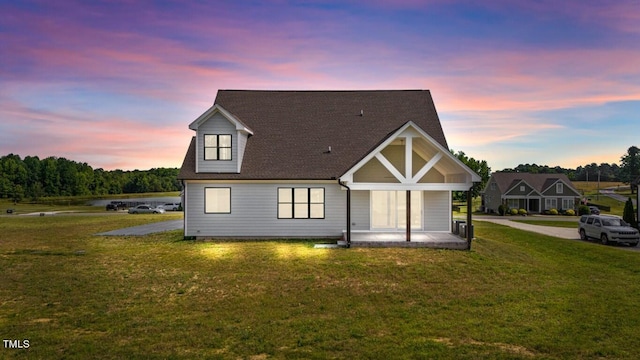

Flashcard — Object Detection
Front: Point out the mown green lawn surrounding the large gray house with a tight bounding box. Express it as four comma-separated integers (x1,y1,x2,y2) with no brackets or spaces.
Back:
0,214,640,359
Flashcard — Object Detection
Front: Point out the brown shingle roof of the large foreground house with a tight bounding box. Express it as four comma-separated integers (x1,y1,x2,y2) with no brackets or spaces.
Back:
179,90,448,180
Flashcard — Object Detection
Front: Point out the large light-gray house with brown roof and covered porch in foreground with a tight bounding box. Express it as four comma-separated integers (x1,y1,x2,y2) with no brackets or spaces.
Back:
179,90,480,246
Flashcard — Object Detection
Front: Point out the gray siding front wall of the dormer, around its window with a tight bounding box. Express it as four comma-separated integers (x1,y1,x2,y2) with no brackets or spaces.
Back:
196,113,239,173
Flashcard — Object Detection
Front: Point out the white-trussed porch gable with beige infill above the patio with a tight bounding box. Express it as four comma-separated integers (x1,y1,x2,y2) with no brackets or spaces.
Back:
340,121,481,191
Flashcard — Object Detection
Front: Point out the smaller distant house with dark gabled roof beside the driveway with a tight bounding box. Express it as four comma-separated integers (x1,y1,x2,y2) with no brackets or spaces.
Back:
483,172,581,213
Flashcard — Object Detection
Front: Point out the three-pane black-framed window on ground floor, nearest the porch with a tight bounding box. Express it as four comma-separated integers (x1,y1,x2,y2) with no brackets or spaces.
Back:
278,188,324,219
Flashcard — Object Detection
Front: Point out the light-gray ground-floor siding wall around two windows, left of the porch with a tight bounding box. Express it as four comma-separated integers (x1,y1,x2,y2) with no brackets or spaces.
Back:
185,182,347,238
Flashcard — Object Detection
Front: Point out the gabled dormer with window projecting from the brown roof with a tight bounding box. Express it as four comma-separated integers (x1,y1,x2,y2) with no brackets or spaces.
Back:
189,104,253,173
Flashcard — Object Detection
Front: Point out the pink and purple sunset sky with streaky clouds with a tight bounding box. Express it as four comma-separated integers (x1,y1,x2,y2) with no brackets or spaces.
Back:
0,0,640,170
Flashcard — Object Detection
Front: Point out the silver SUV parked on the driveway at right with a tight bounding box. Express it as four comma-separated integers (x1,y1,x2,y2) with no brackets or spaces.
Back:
578,215,640,246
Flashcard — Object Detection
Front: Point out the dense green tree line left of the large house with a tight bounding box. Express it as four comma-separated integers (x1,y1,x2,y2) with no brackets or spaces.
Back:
0,154,182,202
